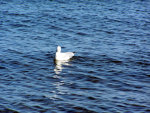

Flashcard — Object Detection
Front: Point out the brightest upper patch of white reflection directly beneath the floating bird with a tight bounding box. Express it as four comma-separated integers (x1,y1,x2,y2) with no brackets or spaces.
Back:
54,60,71,74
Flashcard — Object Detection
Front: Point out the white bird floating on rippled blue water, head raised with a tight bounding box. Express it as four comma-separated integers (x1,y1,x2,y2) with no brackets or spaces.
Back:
55,46,74,61
